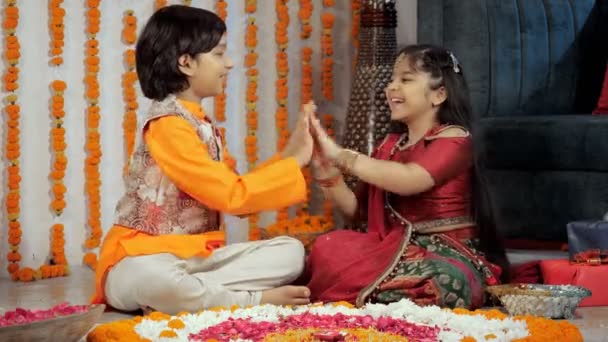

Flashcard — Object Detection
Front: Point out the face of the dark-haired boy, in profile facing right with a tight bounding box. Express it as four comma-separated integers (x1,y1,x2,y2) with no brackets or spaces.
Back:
183,35,233,98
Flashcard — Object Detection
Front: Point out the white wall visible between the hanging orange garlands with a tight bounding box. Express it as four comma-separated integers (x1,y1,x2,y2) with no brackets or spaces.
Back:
0,0,416,277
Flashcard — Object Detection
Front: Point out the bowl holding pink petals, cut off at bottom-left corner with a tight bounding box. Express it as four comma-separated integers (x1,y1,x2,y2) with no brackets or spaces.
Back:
0,304,105,342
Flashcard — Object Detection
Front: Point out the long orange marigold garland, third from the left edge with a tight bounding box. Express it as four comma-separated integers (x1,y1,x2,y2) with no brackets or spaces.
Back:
83,0,103,269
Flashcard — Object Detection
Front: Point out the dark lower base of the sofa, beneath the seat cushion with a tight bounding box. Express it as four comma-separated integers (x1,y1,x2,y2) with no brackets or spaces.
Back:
486,169,608,242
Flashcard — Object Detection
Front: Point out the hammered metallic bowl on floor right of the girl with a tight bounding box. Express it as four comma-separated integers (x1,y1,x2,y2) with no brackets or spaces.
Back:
487,284,591,319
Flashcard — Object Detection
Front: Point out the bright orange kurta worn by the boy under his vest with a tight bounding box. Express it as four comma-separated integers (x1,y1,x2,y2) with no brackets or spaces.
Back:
92,100,306,303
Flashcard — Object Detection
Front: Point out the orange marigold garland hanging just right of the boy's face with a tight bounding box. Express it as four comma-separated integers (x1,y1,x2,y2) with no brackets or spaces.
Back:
245,0,260,230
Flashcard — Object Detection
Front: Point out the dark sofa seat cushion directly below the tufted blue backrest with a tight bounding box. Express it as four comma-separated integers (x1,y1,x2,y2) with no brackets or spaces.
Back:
475,115,608,174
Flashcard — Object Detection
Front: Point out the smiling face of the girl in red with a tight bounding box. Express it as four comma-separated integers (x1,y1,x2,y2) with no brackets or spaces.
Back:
386,55,445,123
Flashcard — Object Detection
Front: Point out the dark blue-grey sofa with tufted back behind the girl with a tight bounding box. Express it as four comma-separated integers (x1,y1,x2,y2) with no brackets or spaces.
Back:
417,0,608,245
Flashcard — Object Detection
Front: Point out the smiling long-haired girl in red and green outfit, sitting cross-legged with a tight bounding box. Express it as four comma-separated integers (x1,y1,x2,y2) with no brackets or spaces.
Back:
304,45,507,308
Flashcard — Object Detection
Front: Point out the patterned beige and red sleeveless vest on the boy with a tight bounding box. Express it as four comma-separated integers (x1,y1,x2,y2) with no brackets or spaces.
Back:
114,96,222,235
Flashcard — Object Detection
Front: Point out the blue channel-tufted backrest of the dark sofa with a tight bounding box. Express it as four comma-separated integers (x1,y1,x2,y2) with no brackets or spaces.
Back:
417,0,608,117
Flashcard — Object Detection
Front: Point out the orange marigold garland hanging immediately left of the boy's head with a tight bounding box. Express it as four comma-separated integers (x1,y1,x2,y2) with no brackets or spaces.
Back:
122,10,138,172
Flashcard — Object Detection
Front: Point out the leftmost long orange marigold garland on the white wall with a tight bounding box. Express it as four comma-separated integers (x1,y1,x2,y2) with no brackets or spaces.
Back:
2,0,22,280
